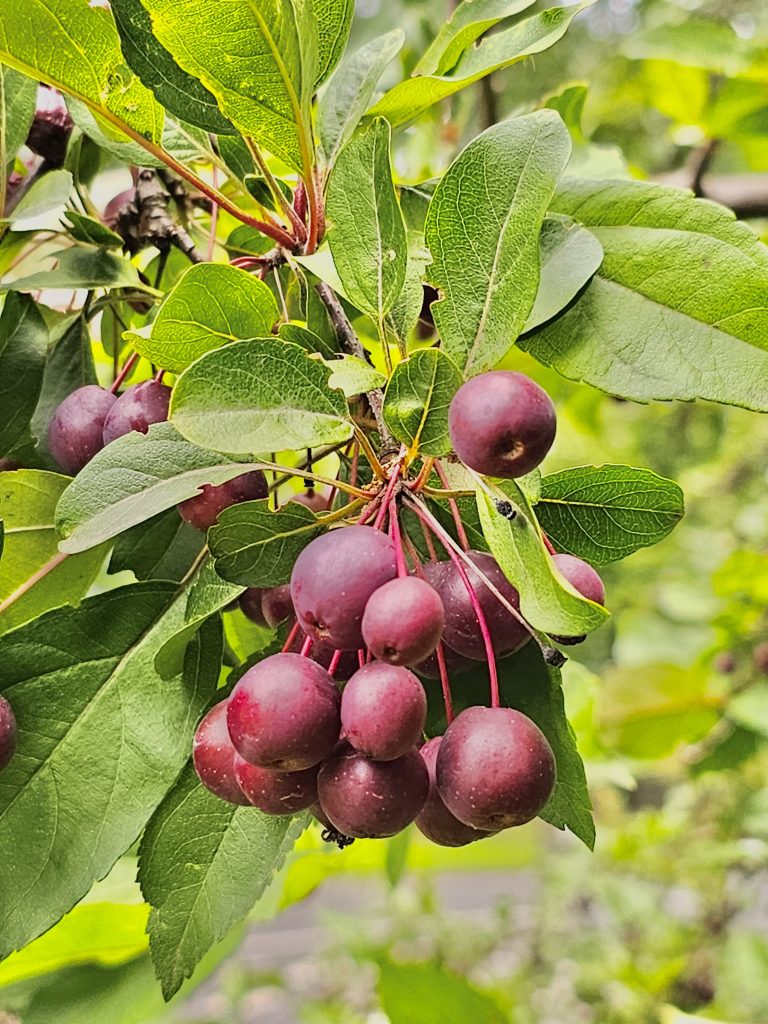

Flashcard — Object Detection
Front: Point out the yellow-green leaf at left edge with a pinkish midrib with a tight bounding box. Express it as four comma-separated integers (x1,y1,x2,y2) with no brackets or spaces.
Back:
0,469,103,632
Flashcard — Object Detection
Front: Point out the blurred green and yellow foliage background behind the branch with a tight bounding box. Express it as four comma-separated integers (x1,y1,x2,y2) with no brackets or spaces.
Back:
0,0,768,1024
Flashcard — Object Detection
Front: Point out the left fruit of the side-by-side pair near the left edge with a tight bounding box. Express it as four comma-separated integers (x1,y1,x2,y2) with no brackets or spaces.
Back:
48,384,117,476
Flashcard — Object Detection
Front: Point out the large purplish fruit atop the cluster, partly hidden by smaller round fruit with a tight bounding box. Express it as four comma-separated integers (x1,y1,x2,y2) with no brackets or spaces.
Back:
291,526,397,650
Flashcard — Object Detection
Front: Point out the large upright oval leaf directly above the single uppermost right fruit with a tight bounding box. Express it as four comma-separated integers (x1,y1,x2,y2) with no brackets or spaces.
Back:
425,111,570,376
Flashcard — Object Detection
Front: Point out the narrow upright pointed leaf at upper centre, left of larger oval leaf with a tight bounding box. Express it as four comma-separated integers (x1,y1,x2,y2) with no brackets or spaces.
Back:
327,118,408,324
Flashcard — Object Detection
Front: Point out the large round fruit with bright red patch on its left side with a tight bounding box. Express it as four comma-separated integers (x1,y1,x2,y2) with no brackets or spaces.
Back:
227,653,341,771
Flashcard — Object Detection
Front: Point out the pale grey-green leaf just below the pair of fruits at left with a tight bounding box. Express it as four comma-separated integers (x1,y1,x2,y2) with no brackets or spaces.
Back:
56,423,250,554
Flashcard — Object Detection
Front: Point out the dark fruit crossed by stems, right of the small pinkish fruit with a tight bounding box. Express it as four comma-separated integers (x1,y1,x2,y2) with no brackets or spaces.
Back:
423,551,530,662
